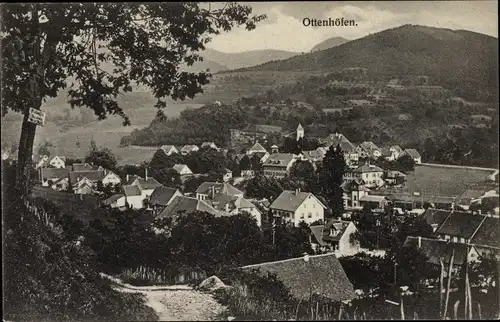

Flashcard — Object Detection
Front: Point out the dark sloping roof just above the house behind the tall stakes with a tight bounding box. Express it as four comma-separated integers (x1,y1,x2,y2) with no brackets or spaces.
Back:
436,211,486,238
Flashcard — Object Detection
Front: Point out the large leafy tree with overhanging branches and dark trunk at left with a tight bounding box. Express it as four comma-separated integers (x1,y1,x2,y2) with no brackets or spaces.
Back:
0,2,265,194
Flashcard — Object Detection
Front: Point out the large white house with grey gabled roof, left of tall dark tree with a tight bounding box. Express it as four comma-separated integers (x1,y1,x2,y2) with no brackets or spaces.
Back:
270,189,326,226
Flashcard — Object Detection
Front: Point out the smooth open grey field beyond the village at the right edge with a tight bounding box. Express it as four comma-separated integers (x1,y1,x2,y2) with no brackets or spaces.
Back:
406,164,494,197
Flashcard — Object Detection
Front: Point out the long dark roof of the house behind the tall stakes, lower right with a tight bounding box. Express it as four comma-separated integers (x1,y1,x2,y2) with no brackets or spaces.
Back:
404,236,471,265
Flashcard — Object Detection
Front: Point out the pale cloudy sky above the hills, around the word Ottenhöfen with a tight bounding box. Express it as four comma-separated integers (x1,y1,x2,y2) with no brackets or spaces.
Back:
207,1,498,53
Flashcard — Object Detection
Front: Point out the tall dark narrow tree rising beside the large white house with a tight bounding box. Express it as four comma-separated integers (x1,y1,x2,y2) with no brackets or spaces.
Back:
318,146,346,217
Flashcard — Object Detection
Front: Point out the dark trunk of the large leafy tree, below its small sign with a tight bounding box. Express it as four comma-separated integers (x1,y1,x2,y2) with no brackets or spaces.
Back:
16,109,36,196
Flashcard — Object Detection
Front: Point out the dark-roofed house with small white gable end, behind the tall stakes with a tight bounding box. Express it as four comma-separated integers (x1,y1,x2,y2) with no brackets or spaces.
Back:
404,236,479,274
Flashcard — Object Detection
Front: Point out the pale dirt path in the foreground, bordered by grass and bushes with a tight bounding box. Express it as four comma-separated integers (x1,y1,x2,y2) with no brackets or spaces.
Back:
101,274,225,321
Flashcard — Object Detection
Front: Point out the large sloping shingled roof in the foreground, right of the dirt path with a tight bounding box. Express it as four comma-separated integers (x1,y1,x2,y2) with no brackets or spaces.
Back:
241,253,357,302
